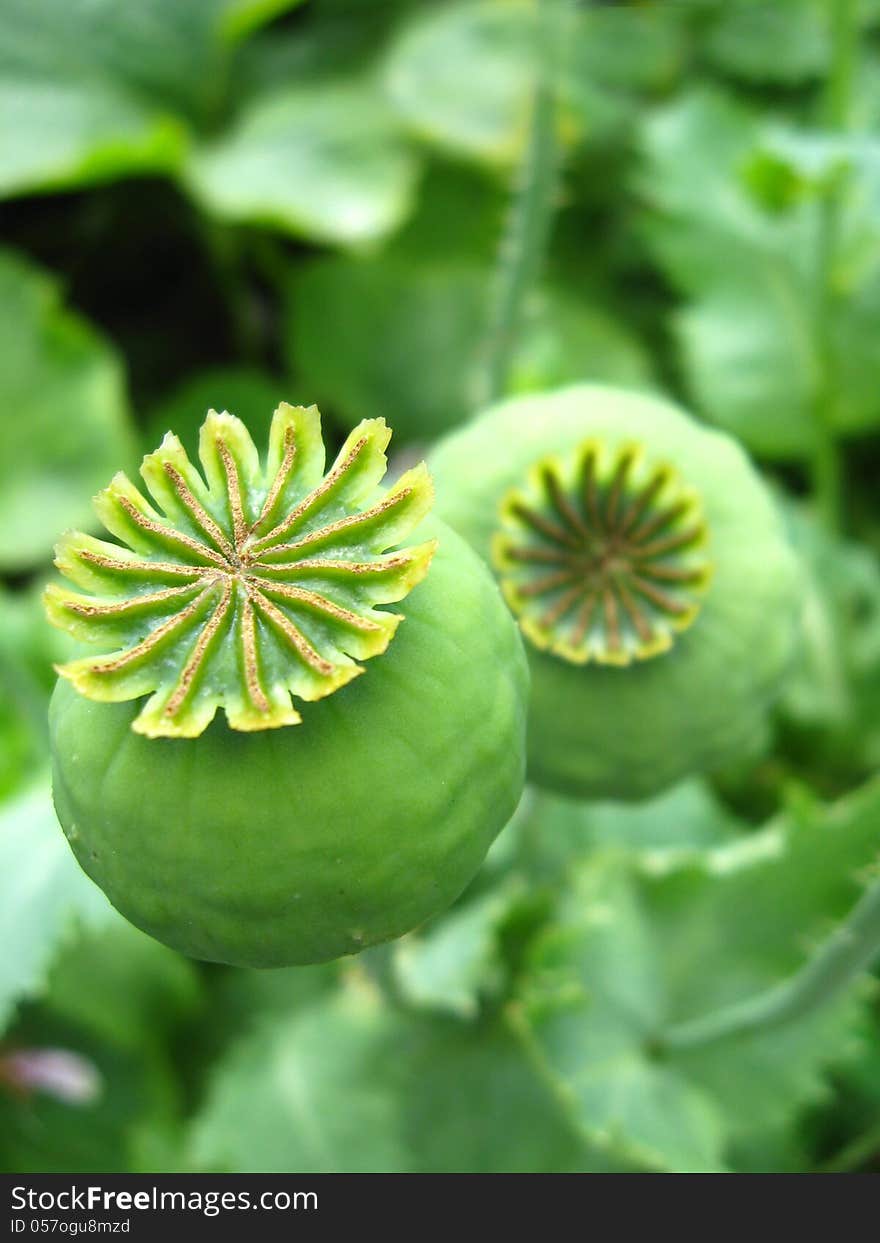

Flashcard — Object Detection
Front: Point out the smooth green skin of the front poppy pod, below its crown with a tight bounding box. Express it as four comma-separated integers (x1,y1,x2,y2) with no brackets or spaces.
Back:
50,523,528,967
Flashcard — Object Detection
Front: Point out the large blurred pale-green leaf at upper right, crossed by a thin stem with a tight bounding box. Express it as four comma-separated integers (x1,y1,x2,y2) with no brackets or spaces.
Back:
639,89,880,457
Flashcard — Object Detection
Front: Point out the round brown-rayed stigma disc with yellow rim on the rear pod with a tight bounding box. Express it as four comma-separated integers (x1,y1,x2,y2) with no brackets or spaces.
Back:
492,440,711,666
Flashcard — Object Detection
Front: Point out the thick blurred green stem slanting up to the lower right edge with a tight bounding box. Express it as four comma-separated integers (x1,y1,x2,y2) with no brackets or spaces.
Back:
660,879,880,1050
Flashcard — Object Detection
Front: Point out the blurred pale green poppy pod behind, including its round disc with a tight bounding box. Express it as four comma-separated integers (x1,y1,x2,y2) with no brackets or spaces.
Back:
431,385,798,799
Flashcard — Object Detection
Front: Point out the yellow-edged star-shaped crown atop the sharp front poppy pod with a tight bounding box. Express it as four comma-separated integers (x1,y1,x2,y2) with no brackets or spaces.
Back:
45,404,435,737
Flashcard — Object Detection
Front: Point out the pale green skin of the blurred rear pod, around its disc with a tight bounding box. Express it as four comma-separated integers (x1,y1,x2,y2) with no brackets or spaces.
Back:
430,384,799,799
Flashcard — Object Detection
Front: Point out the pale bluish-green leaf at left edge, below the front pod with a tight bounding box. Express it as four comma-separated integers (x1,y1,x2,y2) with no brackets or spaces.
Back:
0,778,114,1028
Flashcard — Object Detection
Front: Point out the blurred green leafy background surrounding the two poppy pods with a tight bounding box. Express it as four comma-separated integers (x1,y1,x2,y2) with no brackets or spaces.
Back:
0,0,880,1171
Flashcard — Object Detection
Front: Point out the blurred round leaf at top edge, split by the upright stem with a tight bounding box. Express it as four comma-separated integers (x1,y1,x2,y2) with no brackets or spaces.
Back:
384,0,685,169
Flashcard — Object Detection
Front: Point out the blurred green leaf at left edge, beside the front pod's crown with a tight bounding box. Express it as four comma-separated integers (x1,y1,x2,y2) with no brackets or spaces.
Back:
0,251,134,571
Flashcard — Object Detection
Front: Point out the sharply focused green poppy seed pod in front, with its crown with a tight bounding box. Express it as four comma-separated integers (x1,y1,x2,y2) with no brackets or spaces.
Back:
46,405,528,967
